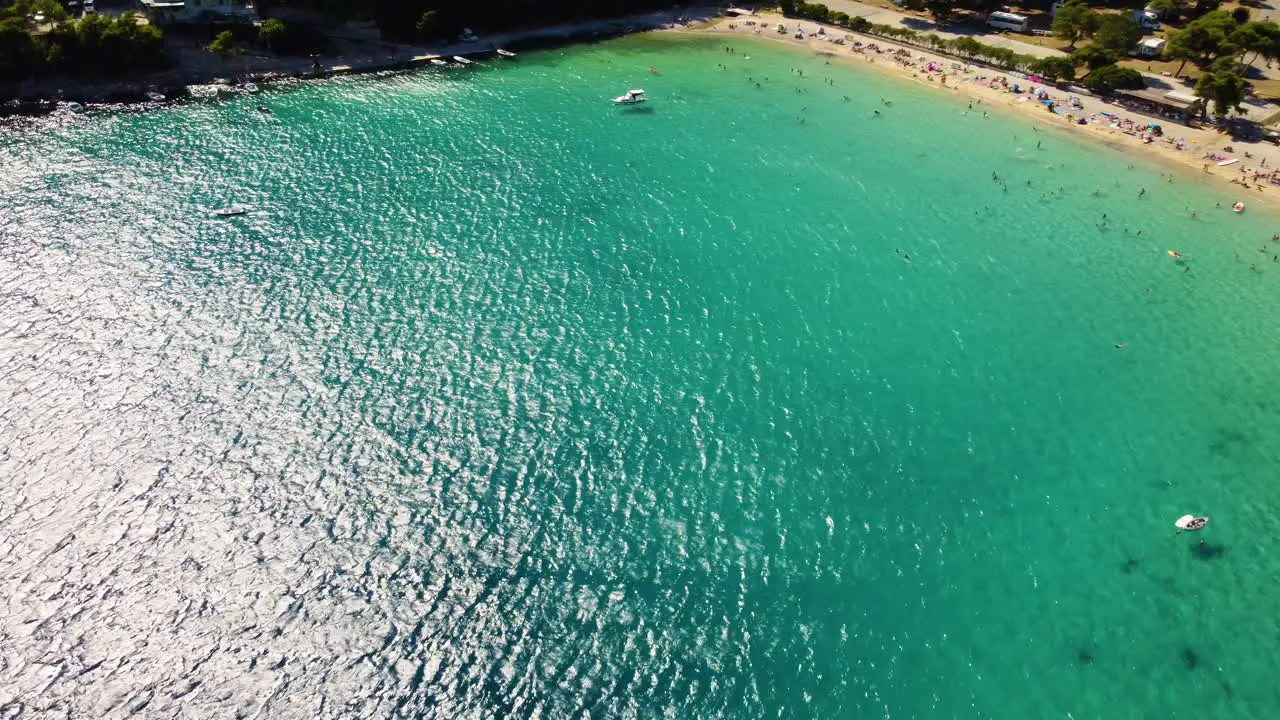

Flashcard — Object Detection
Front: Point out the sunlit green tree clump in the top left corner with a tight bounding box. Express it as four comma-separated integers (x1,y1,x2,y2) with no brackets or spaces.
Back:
0,0,168,82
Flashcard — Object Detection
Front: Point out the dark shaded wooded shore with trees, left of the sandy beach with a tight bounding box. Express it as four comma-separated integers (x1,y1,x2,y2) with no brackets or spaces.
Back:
0,0,716,111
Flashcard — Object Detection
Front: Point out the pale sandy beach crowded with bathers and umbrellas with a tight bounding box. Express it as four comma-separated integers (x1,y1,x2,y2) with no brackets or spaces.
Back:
663,13,1280,208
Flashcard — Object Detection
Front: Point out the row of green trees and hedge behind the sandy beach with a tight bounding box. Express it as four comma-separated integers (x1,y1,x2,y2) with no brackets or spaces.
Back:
781,0,1280,115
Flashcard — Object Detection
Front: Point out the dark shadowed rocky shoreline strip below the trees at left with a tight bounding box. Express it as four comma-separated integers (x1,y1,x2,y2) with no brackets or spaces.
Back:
0,8,716,118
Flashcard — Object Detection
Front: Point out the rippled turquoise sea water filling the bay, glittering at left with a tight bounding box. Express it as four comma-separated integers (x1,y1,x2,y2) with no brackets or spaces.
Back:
0,37,1280,719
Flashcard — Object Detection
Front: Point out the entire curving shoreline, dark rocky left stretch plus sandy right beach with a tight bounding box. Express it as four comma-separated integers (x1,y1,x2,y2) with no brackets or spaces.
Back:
10,8,1280,209
